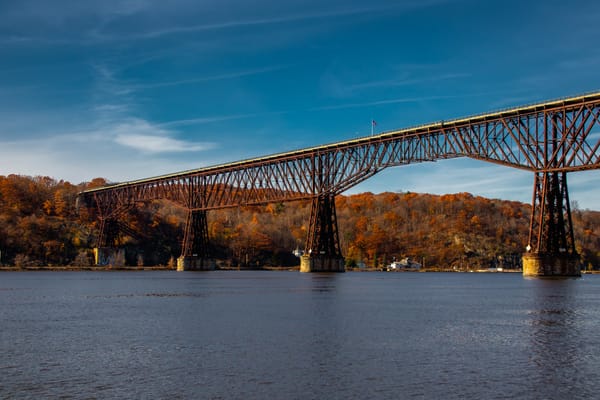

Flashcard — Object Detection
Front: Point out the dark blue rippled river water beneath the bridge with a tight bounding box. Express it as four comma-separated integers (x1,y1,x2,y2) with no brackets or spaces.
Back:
0,271,600,399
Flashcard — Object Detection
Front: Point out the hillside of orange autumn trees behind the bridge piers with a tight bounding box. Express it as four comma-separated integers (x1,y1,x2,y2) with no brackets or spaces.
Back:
0,175,600,268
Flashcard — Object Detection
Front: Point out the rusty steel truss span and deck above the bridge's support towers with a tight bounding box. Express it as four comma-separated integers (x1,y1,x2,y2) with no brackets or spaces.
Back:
80,92,600,212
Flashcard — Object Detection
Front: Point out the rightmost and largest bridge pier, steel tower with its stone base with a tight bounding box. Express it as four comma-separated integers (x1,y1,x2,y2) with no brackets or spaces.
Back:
523,172,581,277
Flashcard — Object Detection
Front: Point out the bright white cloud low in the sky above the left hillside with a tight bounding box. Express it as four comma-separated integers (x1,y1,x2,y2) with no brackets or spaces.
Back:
0,114,217,183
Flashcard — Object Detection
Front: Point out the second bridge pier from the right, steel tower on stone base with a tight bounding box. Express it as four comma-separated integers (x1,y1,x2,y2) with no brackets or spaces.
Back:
300,194,346,272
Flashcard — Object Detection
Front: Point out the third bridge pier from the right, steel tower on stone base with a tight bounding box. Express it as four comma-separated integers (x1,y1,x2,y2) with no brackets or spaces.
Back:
177,210,216,271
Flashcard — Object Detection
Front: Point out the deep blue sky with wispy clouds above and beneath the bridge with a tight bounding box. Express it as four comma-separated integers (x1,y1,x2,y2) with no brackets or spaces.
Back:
0,0,600,210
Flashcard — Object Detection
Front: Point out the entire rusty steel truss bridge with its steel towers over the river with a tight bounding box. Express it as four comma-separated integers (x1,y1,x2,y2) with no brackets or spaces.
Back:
80,92,600,276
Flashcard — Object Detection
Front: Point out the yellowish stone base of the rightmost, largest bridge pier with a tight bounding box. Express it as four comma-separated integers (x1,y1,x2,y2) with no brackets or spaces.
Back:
523,253,581,277
